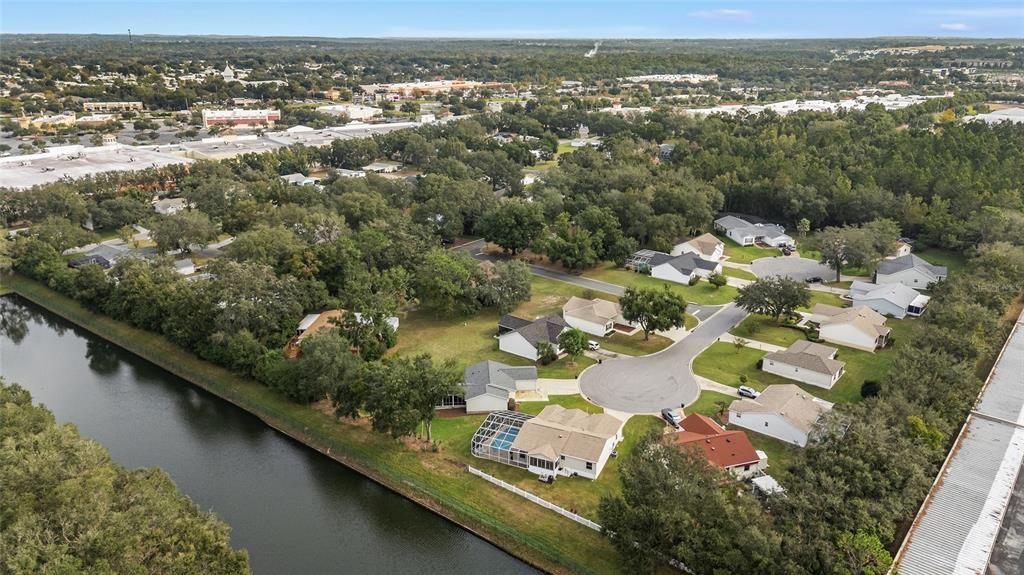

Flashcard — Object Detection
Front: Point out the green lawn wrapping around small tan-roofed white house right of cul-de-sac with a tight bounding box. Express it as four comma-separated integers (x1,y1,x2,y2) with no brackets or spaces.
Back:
693,319,913,403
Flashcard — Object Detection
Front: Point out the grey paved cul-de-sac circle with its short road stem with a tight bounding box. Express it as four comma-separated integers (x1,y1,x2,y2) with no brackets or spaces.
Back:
580,304,746,413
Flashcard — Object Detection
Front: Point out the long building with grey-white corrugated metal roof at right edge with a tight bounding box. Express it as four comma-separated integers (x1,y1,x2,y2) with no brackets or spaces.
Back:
894,308,1024,575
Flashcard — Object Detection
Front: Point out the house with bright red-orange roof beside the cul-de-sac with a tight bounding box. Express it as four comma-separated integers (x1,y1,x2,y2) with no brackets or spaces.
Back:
673,413,768,479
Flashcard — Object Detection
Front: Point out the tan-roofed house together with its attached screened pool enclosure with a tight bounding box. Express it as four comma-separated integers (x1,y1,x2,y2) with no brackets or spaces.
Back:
470,405,625,479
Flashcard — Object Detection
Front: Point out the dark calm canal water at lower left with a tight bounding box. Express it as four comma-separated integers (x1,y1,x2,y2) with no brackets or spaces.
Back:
0,298,534,575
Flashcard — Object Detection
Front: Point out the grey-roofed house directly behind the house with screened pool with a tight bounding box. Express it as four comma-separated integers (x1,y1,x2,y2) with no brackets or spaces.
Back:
438,359,537,413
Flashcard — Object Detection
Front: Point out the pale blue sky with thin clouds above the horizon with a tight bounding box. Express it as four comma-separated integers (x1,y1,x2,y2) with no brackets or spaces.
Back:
6,0,1024,39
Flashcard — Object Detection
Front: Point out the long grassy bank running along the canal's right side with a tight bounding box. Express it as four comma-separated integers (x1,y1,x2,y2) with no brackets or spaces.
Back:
5,276,617,573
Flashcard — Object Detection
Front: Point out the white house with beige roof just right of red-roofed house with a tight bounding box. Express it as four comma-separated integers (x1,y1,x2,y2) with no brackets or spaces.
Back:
729,384,833,447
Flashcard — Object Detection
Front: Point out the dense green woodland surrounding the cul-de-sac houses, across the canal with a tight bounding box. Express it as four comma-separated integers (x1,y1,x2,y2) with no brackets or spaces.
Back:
6,95,1024,574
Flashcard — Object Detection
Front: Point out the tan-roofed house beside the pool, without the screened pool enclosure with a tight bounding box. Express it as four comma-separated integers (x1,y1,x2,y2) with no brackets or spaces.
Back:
511,405,624,479
